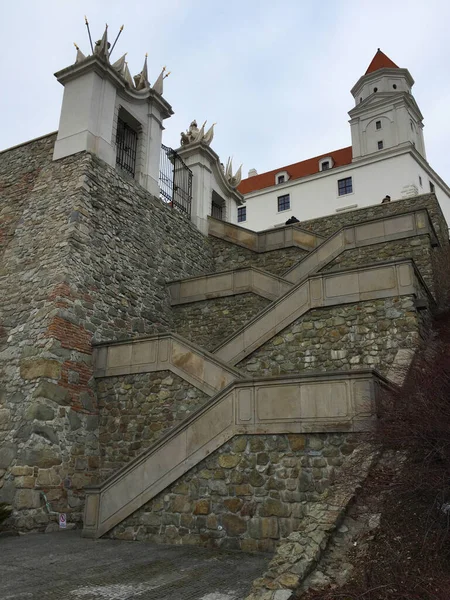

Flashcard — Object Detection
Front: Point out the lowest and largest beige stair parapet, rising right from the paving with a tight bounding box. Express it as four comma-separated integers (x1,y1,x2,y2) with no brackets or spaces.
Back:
83,369,389,537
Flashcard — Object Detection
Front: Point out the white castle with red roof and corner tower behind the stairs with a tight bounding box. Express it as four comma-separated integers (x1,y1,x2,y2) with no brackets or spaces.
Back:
236,49,450,231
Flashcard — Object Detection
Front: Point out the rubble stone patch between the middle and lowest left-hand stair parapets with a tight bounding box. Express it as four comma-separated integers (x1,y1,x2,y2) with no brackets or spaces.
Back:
173,294,270,352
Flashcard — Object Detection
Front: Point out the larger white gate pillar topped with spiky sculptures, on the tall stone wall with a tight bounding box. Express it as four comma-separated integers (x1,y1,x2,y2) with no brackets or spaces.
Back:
53,27,173,196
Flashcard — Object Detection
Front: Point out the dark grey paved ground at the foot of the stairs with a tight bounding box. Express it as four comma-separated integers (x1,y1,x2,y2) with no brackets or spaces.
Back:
0,531,270,600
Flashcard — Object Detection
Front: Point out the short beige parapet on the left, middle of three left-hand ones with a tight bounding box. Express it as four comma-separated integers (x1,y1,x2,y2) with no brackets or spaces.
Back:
168,267,293,306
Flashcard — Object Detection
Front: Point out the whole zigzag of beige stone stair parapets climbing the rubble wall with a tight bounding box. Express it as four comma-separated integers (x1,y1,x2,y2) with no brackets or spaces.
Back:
83,209,436,537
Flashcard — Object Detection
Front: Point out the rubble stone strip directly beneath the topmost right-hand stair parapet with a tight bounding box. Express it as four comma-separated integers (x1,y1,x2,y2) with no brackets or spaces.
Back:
321,235,434,292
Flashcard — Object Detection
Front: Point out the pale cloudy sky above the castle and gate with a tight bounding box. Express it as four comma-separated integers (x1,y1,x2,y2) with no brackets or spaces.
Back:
0,0,450,184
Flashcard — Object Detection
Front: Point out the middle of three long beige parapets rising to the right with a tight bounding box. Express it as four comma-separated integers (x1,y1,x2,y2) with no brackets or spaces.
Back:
214,259,430,364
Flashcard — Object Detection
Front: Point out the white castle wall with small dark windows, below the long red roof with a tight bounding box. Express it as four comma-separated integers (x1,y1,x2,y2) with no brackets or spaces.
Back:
237,152,450,231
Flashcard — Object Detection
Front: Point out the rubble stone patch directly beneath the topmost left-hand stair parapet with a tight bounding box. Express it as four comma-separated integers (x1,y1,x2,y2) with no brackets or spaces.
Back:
209,236,308,275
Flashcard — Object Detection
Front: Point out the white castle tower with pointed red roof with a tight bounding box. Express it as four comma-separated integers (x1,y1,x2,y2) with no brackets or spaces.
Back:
349,48,425,162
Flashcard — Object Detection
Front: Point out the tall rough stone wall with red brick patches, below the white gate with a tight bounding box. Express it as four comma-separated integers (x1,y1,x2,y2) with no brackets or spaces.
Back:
0,138,213,527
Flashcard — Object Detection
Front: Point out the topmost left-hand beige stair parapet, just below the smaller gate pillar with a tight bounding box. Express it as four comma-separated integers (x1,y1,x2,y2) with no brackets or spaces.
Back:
208,216,324,253
